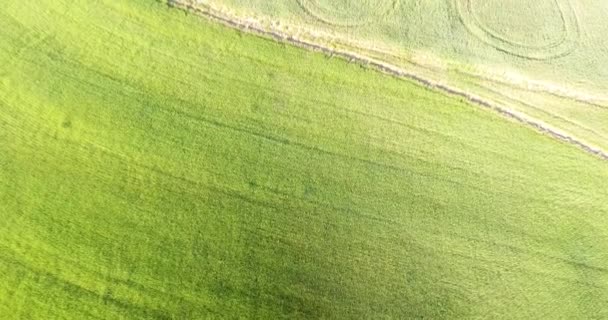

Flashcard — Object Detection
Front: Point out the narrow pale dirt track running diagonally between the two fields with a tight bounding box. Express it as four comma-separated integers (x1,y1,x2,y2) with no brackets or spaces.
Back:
167,0,608,160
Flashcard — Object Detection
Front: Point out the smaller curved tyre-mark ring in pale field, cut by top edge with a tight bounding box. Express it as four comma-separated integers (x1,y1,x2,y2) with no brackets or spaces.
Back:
296,0,400,27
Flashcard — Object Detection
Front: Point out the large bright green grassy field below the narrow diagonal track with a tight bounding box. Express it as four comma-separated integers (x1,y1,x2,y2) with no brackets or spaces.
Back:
0,0,608,319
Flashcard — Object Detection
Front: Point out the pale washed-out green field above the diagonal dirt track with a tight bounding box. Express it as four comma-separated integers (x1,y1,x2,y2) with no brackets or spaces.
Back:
196,0,608,150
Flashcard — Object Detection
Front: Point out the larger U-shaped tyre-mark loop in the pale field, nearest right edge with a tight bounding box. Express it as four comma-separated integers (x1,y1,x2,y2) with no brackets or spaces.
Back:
453,0,580,60
